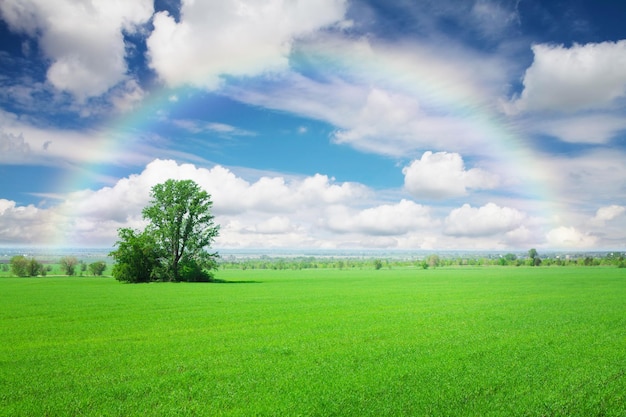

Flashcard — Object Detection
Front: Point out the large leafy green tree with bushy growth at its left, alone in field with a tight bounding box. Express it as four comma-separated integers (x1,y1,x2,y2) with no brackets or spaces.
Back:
111,179,219,282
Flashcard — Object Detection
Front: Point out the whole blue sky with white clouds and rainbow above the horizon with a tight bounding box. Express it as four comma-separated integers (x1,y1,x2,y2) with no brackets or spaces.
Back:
0,0,626,251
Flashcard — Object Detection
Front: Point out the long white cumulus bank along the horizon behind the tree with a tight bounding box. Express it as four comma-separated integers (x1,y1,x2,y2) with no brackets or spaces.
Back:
0,160,624,250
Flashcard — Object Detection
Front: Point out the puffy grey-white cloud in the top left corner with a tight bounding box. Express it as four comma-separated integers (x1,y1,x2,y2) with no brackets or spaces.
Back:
0,0,154,101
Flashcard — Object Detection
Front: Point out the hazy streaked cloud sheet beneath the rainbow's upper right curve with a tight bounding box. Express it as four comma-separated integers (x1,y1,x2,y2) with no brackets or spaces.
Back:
224,34,510,156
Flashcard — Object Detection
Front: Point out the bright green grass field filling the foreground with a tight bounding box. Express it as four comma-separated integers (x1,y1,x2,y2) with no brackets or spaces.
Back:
0,267,626,416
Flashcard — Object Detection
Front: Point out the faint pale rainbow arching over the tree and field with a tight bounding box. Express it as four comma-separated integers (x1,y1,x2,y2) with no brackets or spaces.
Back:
54,46,558,247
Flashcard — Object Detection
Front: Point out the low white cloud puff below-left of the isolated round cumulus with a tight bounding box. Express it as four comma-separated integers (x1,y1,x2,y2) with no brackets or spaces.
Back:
321,200,437,236
